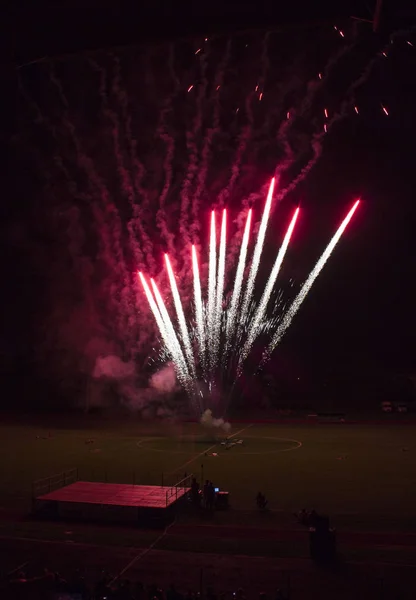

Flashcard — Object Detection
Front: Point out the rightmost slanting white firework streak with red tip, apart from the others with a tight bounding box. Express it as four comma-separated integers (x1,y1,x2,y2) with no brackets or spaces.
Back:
261,200,360,364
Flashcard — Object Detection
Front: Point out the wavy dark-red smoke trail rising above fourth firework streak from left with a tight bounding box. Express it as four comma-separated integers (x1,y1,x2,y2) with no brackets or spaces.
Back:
191,39,231,241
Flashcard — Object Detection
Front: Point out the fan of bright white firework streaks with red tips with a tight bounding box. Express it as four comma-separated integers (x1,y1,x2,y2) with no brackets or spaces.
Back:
139,178,360,413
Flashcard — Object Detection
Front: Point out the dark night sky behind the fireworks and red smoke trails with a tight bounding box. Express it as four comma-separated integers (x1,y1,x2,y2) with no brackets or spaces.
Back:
0,3,416,406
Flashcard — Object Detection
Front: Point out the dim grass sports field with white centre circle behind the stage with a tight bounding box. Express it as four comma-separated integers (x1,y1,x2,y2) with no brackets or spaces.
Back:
0,420,416,518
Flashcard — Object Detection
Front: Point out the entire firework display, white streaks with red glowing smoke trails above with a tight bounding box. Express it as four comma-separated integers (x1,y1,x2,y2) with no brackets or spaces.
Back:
13,20,415,417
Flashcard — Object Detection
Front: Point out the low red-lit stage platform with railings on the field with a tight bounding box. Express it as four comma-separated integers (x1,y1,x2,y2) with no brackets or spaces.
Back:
33,478,190,527
